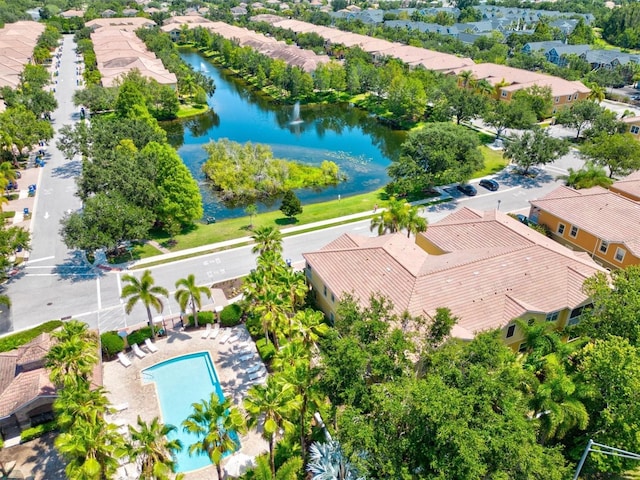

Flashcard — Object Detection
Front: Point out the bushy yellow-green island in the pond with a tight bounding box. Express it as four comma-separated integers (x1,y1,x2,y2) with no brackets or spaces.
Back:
202,138,346,203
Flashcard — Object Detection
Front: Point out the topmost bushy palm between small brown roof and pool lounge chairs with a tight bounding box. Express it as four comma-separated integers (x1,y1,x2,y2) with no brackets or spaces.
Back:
45,320,98,386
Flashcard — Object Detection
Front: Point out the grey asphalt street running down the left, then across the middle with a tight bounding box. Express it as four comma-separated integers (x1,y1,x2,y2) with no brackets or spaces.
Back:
0,36,582,333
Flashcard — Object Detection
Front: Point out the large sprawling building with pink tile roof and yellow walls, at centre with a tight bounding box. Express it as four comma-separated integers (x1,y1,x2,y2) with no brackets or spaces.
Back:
304,208,605,349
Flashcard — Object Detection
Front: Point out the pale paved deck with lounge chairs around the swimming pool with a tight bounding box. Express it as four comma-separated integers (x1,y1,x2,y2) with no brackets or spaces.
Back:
103,325,268,480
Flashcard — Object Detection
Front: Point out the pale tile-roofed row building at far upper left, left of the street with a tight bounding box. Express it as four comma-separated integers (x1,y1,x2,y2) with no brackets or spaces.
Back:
0,20,44,88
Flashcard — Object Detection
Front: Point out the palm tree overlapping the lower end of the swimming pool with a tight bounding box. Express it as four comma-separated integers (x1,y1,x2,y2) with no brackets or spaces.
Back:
182,392,246,480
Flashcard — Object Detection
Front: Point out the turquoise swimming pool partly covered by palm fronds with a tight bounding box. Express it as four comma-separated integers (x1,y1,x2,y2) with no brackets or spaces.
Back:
142,352,239,472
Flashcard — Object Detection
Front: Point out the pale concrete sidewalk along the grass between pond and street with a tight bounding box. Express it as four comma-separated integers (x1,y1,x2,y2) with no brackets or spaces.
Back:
129,188,452,268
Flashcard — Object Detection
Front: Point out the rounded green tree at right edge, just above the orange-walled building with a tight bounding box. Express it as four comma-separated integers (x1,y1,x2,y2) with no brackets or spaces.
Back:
580,133,640,178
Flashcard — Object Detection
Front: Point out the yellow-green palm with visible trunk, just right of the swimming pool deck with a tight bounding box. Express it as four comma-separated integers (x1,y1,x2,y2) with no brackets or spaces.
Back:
244,376,300,476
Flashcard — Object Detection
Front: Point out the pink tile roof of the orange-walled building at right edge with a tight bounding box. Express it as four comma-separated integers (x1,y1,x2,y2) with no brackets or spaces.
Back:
530,187,640,256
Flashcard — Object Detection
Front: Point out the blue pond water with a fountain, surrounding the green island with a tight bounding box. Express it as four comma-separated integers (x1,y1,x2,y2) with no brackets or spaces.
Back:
163,51,405,219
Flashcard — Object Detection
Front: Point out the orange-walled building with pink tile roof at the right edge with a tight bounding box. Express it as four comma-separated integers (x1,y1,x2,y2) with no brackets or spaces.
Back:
529,187,640,269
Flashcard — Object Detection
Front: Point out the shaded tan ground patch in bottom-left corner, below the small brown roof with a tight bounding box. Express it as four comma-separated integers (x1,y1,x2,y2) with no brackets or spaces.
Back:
0,433,67,480
